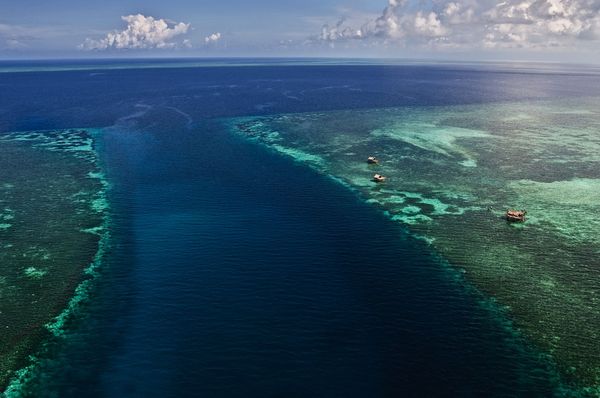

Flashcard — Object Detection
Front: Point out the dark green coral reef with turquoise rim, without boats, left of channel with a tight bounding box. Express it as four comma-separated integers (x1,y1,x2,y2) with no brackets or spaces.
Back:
0,129,108,396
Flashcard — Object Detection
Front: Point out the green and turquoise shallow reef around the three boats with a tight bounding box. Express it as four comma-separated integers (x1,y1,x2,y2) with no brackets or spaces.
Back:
225,97,600,392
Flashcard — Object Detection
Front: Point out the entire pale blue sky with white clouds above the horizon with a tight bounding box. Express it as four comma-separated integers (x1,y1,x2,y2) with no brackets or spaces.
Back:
0,0,600,64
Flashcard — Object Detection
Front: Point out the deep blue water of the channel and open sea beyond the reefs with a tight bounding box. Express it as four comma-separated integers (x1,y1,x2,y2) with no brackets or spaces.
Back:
0,60,600,397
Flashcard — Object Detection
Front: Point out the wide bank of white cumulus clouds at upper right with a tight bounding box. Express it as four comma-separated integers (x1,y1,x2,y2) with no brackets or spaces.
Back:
309,0,600,51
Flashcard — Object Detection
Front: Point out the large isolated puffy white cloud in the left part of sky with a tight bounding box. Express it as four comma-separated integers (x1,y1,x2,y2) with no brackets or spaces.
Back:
79,14,190,50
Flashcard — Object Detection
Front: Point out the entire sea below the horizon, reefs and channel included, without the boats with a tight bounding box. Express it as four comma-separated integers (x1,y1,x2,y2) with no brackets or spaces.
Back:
0,59,600,397
